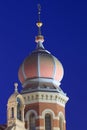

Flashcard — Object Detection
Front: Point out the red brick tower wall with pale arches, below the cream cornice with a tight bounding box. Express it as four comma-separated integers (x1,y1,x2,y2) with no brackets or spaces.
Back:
25,102,65,130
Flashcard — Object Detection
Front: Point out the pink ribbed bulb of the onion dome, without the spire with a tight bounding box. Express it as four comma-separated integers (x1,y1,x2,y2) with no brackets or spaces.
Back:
18,48,64,86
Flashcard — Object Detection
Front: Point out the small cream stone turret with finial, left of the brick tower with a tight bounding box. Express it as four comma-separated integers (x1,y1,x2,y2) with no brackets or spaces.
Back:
6,83,25,130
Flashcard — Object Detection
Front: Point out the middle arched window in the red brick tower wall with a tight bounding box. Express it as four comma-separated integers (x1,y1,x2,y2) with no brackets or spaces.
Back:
45,114,52,130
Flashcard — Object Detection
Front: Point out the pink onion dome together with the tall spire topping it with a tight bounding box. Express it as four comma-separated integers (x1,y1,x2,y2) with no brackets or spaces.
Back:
18,4,64,88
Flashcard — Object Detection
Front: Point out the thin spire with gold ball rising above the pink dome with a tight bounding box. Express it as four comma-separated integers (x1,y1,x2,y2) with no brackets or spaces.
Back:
35,4,44,49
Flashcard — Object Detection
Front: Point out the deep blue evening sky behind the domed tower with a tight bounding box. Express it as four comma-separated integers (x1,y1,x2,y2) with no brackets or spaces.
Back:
0,0,87,130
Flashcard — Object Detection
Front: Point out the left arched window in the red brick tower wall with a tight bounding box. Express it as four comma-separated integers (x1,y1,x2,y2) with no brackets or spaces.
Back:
29,113,36,130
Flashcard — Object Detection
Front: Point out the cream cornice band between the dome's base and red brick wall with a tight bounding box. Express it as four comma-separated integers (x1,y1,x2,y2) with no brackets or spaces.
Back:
22,92,68,107
